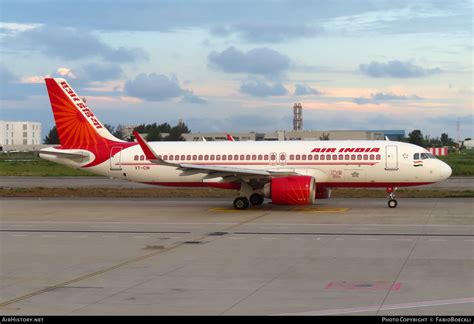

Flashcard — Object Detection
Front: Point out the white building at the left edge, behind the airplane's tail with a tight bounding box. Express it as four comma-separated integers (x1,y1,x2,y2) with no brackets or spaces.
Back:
0,120,41,150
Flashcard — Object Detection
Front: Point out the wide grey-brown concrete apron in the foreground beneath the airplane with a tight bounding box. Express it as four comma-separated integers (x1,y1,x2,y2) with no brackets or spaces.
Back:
0,198,474,315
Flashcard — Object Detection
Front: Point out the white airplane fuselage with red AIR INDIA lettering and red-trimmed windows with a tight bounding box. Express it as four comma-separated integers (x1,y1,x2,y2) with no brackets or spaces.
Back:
40,141,451,187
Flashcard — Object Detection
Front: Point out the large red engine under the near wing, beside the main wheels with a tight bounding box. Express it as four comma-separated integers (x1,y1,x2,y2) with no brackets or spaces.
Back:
263,176,316,205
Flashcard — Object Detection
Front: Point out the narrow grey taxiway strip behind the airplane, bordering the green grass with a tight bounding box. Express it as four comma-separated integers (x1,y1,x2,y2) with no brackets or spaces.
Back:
0,176,474,190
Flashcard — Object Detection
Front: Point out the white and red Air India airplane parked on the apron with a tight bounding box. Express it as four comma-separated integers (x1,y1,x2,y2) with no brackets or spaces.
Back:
39,78,451,210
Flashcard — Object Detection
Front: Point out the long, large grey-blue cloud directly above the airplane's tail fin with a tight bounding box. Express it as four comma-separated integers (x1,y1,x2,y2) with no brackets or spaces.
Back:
5,26,147,62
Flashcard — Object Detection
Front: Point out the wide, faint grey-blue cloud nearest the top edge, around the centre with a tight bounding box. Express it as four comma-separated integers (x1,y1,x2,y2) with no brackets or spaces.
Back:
210,20,323,43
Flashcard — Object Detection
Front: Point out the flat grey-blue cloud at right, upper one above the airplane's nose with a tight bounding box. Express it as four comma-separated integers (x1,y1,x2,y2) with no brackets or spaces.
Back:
359,60,442,78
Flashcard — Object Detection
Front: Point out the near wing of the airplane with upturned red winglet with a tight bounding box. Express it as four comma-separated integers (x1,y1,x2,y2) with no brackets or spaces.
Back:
133,132,296,181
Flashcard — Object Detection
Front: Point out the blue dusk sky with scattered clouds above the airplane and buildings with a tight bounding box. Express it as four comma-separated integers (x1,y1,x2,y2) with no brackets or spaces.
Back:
0,0,474,139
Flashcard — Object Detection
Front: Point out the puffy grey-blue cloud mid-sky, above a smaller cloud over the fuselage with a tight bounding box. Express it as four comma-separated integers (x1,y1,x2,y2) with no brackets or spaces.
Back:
208,46,290,76
